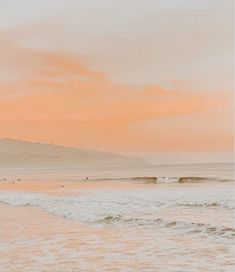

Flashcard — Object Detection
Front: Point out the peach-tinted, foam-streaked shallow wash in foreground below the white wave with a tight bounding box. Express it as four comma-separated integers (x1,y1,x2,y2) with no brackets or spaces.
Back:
0,201,233,272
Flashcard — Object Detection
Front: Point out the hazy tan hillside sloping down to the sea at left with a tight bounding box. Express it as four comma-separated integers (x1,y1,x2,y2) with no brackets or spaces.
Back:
0,139,144,168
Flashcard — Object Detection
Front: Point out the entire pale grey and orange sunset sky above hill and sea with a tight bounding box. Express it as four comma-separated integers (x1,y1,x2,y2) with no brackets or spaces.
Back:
0,0,234,163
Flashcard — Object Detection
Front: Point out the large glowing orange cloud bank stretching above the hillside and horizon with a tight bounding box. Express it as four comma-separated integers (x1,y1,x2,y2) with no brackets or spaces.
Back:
0,33,232,152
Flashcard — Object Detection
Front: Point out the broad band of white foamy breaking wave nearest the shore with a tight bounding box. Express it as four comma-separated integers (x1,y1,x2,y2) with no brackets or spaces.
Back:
0,186,234,242
